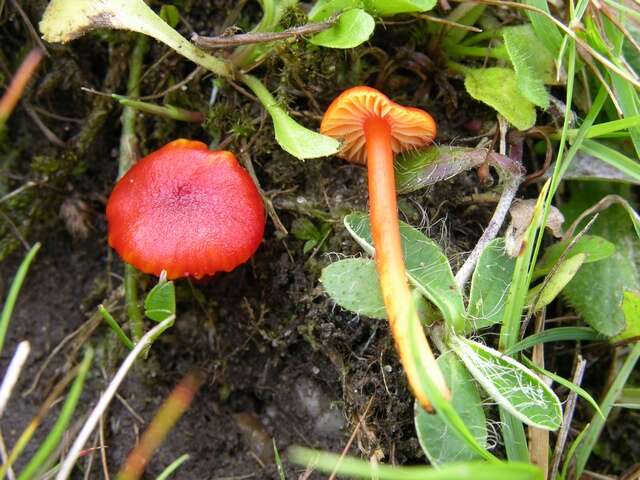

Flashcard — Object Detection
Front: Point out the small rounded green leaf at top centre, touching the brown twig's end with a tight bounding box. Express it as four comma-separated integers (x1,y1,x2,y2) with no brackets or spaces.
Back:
309,8,376,48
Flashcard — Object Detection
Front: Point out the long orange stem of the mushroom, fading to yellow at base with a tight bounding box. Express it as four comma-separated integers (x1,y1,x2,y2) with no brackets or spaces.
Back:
364,117,450,410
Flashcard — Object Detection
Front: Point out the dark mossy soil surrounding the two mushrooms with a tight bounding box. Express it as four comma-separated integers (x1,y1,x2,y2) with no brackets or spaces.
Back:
0,0,637,479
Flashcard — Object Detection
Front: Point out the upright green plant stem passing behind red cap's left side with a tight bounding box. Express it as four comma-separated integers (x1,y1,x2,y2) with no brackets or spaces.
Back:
118,35,149,342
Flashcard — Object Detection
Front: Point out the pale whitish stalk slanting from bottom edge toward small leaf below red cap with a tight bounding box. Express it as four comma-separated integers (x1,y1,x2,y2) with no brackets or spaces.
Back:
56,315,175,480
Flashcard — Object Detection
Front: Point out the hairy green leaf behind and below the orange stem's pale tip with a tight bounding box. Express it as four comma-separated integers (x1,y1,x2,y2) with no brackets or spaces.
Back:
414,352,487,466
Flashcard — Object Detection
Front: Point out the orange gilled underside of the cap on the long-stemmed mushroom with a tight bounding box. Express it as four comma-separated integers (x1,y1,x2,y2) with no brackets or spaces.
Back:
320,87,436,164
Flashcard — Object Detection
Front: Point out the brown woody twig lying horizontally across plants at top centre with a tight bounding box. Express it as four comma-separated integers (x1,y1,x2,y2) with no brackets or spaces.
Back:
191,17,337,49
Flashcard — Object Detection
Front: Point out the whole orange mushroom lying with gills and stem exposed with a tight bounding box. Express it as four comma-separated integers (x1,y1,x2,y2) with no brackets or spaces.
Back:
320,87,450,410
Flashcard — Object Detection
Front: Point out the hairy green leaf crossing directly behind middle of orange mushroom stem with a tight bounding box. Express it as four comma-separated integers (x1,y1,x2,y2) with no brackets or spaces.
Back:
344,213,464,329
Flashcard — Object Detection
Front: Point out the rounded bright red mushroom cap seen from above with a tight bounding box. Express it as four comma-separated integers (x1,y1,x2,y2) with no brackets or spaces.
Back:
107,140,265,279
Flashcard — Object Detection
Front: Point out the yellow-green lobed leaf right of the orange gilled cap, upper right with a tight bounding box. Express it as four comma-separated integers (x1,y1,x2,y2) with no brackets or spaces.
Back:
464,67,536,130
